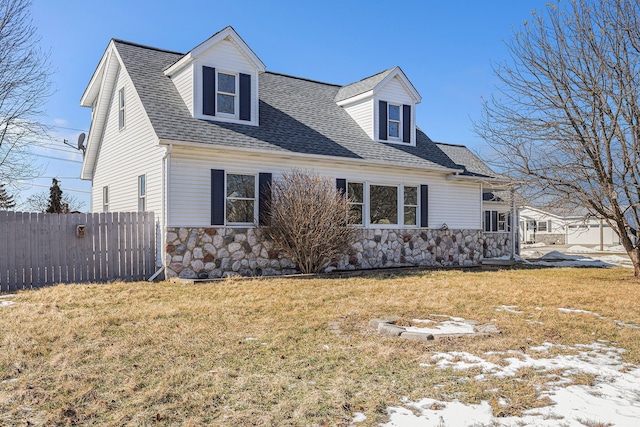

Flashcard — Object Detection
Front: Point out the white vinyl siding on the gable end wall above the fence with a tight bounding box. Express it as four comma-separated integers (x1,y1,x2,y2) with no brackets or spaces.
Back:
91,69,165,219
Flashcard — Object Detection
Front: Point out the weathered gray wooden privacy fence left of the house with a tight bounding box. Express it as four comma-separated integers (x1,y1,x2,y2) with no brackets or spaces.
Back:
0,210,156,291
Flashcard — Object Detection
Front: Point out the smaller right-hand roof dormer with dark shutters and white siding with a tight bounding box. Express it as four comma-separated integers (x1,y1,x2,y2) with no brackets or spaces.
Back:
335,67,422,146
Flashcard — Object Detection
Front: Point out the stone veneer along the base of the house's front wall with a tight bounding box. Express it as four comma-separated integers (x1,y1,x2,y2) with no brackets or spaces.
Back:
165,227,511,279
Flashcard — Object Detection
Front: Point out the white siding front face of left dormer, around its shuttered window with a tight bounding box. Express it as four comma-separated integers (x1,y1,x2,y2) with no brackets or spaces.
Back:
192,40,259,125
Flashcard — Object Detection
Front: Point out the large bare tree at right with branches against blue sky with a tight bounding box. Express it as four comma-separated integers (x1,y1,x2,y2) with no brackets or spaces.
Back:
474,0,640,278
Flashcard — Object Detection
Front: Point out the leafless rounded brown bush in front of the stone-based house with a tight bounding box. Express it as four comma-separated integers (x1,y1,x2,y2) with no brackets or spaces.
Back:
261,170,358,273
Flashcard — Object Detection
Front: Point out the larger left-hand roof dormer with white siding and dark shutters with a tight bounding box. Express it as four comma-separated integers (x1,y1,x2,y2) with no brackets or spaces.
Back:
164,27,265,126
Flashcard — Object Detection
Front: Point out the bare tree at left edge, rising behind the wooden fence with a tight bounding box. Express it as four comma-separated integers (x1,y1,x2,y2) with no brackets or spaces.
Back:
0,0,51,187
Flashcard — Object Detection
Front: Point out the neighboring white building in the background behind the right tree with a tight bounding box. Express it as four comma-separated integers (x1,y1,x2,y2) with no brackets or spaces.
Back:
519,206,620,245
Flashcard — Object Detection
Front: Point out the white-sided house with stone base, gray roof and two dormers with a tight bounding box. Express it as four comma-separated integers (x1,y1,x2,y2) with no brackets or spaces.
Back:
81,27,511,278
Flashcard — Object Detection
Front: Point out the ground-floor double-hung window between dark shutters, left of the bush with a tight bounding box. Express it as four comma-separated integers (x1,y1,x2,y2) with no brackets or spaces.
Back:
226,173,256,224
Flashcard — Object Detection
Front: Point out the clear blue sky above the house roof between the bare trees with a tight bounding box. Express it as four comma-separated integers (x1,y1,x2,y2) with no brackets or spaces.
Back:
20,0,546,210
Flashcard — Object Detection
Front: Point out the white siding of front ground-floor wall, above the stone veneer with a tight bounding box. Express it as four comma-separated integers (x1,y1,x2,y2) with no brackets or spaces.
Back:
167,146,482,229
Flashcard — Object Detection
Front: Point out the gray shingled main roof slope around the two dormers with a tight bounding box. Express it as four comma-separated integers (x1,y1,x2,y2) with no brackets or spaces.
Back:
114,40,461,169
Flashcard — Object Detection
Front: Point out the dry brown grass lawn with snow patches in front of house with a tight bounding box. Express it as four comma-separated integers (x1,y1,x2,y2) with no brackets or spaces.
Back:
0,269,640,426
